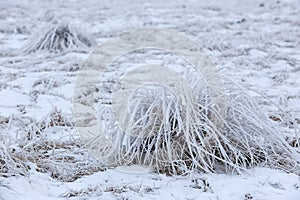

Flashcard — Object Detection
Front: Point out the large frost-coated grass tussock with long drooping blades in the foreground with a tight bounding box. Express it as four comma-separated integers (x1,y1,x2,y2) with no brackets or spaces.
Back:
90,69,300,174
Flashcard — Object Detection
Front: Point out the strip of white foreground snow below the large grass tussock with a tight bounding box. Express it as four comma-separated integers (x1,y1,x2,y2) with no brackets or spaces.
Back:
0,168,300,200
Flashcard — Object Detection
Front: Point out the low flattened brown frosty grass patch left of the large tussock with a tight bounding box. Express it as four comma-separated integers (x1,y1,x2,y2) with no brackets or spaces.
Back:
0,109,104,181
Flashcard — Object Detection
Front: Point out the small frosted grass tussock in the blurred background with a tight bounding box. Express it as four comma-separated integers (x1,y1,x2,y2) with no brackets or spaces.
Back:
23,22,92,53
